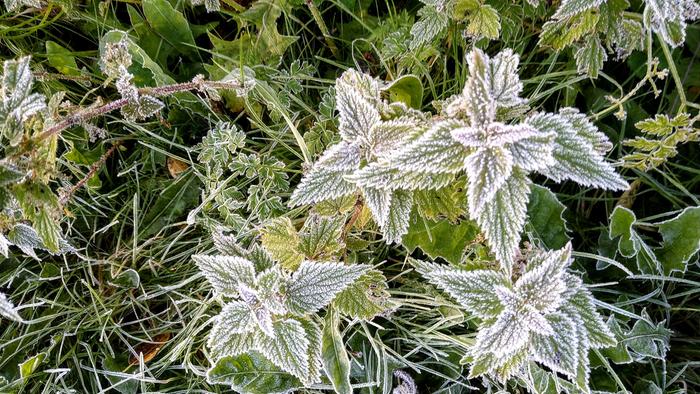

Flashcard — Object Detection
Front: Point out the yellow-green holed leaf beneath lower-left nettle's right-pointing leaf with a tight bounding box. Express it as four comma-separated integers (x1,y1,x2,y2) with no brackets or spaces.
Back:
333,270,390,320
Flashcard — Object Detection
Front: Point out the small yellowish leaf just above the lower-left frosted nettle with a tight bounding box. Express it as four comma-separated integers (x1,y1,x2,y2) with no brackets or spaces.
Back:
261,217,304,270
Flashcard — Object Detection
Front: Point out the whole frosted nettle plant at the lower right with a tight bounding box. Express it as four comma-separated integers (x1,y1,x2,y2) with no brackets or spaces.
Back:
414,244,616,392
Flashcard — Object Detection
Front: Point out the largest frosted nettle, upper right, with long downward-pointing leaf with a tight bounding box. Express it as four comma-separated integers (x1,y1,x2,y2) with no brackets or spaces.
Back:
352,49,627,272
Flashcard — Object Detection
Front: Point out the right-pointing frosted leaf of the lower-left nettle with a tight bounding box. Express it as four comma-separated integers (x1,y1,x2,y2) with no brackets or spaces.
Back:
287,261,370,315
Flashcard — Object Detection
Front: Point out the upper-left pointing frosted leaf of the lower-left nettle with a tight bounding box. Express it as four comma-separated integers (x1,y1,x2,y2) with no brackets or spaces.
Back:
192,255,255,297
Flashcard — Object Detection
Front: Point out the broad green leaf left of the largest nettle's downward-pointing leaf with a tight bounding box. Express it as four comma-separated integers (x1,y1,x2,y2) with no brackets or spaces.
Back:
401,218,479,264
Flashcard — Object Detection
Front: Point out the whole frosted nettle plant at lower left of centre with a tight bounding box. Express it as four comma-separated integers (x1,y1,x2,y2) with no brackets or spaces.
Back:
193,248,370,384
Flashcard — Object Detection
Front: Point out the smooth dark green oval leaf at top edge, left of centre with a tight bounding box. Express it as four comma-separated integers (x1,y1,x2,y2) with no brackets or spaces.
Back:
142,0,196,54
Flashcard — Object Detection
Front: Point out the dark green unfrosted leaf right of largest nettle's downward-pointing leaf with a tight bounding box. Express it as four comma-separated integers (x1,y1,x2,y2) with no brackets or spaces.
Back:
526,184,571,249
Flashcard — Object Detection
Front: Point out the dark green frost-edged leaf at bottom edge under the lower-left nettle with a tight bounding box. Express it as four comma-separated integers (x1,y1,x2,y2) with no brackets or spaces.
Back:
207,351,303,394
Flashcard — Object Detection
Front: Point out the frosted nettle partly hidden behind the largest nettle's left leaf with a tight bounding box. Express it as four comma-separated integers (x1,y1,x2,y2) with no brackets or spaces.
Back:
290,70,428,243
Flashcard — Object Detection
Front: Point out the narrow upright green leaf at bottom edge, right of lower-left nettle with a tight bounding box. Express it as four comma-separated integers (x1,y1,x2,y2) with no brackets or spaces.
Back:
321,308,353,394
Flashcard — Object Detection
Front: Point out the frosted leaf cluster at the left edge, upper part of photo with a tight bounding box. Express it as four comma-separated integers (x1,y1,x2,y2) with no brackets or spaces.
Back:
0,56,46,146
